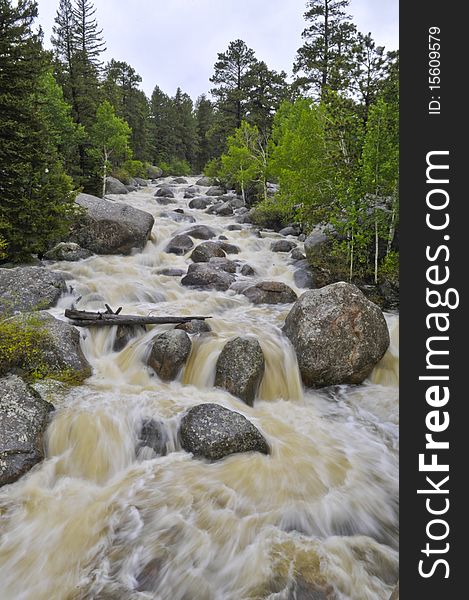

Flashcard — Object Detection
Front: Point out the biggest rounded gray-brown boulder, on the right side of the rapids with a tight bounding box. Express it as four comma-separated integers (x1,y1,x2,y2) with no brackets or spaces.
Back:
283,282,389,387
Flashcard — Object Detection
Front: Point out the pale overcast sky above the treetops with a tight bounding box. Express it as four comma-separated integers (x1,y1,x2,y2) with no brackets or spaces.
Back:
37,0,399,99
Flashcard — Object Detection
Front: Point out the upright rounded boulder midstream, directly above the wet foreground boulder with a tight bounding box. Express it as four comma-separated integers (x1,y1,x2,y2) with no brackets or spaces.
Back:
215,337,265,406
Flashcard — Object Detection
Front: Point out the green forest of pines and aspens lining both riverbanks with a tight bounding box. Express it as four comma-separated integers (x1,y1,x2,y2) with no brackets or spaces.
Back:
0,0,399,288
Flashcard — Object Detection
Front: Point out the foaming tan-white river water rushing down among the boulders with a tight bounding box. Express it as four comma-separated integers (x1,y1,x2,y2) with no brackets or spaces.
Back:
0,179,398,600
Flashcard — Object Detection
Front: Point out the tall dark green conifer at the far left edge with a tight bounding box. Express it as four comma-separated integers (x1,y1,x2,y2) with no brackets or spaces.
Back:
0,0,74,260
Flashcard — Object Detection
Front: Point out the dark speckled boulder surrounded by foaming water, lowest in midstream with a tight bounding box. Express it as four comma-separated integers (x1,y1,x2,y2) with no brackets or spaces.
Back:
179,404,270,460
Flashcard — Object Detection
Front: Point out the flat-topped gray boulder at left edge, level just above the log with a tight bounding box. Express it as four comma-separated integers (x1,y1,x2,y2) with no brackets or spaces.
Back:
0,267,66,316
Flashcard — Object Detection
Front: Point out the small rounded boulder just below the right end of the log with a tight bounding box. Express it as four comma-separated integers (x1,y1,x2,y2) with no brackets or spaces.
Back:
148,329,192,381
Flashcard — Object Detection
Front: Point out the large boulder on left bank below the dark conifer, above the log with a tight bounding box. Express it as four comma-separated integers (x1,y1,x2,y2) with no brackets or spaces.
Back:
70,194,155,254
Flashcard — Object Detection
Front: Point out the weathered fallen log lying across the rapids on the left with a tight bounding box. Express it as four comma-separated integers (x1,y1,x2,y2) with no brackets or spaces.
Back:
65,306,211,327
